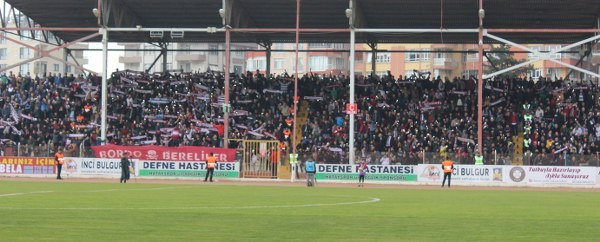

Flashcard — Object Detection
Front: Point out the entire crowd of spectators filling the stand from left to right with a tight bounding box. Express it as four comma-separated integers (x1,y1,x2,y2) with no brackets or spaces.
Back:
0,70,600,165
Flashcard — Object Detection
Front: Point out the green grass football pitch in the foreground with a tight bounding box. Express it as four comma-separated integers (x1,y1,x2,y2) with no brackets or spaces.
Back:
0,180,600,241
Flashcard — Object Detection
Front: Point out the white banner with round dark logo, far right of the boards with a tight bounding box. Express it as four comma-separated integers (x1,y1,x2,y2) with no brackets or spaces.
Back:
504,166,598,185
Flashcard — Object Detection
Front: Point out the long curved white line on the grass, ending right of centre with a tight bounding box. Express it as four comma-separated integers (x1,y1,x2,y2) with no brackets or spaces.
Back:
0,197,381,210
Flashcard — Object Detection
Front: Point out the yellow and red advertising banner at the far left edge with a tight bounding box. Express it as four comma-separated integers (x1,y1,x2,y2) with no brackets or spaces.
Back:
0,156,56,174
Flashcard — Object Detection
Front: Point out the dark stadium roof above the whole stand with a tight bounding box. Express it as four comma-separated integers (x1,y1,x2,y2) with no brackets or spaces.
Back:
5,0,600,44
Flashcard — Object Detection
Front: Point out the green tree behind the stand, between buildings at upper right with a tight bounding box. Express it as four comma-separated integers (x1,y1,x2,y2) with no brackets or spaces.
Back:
484,44,534,77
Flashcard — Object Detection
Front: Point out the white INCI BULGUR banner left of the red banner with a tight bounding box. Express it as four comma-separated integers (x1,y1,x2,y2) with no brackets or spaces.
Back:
62,157,136,177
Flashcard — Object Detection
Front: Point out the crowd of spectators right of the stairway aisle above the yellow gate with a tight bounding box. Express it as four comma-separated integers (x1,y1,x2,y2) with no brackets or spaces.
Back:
300,74,600,165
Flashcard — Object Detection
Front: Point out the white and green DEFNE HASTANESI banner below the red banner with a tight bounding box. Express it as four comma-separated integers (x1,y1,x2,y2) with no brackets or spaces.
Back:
138,160,240,179
